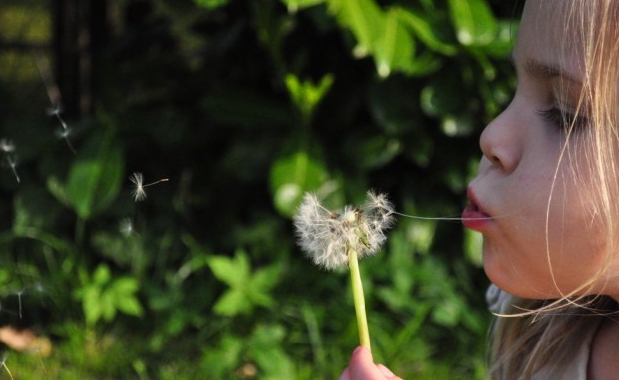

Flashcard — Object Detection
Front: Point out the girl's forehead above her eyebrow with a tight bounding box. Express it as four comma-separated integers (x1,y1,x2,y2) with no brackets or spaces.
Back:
514,0,584,78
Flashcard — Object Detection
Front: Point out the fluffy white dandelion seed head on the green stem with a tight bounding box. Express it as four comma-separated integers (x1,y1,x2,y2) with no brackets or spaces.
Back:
293,192,395,270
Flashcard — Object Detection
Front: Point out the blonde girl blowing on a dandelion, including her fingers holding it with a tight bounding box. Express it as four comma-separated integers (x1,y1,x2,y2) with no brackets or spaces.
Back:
341,0,619,380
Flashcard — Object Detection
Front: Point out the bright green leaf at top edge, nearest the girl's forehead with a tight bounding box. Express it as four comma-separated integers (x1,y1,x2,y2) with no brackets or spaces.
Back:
449,0,497,46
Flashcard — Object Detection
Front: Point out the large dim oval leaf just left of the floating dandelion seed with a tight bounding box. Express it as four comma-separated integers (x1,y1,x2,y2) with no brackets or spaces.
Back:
65,123,124,220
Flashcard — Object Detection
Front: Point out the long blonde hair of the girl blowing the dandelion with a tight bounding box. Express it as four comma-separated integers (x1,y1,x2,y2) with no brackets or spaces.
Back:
489,0,619,380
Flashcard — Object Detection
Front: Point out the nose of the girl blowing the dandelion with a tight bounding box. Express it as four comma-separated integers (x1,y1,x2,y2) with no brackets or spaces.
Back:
479,101,521,174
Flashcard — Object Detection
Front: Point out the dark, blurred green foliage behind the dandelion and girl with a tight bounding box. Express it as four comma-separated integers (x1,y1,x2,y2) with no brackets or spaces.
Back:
0,0,519,379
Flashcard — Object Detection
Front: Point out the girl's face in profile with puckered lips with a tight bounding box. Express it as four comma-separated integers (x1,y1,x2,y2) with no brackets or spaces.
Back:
463,0,618,299
